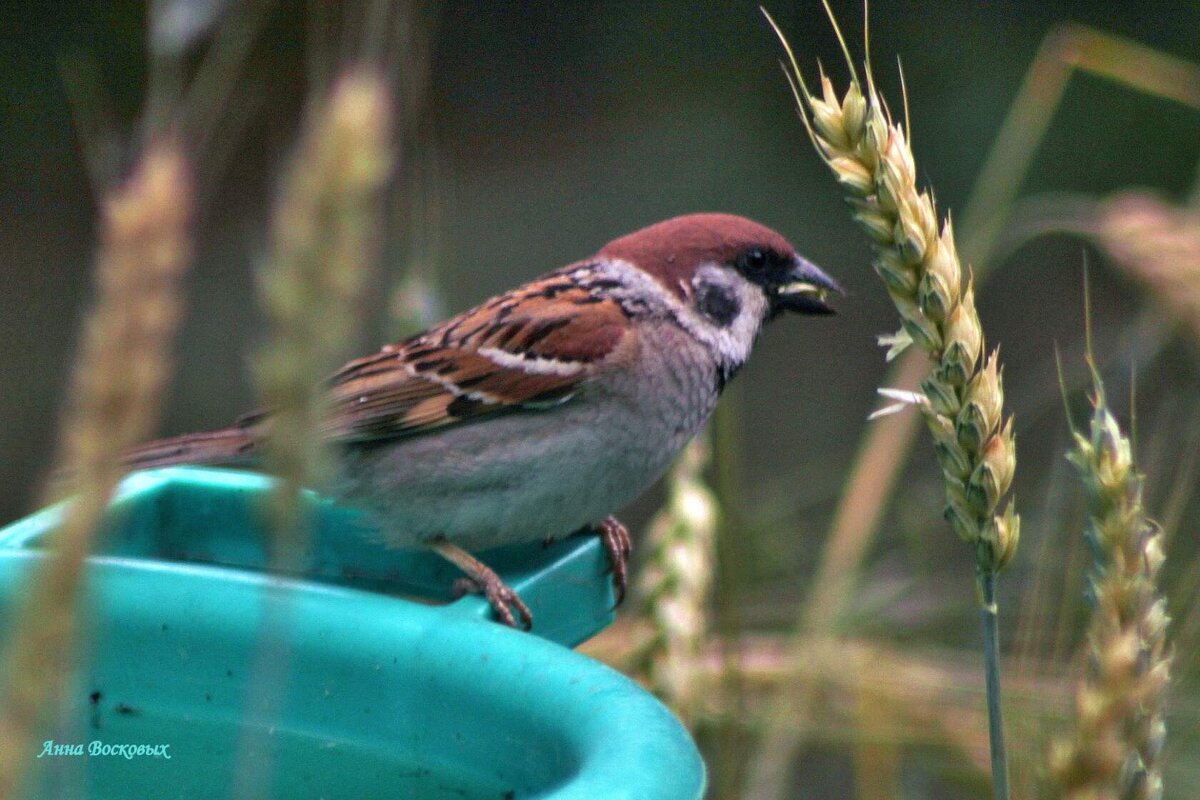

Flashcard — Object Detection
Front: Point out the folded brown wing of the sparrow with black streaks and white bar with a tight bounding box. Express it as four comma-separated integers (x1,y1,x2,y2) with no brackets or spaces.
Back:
325,267,635,441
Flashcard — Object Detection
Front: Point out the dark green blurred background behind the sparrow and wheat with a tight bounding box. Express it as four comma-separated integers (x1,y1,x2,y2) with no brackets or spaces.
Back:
0,0,1200,798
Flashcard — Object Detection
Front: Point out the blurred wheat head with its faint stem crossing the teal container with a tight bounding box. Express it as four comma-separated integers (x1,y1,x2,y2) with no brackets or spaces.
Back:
225,67,392,796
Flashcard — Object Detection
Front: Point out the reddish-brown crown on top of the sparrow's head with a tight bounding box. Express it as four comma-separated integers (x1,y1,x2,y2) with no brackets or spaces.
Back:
596,213,796,299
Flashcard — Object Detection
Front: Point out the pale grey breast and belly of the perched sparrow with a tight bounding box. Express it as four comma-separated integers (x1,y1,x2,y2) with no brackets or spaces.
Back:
334,319,718,551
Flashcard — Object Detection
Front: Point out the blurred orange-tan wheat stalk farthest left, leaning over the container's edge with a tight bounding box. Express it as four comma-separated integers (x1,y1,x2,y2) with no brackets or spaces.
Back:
0,140,192,798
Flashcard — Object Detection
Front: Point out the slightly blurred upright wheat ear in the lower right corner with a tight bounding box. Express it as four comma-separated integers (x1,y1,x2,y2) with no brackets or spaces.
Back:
1050,366,1171,800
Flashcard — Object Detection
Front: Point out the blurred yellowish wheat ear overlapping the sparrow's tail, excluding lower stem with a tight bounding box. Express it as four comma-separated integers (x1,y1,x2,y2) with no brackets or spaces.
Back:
254,71,392,551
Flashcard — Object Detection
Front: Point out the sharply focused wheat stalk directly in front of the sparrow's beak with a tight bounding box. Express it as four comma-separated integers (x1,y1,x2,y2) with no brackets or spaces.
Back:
763,9,1020,798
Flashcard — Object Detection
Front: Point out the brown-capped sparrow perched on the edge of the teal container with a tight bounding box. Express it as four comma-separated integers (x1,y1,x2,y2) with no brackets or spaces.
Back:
126,213,841,628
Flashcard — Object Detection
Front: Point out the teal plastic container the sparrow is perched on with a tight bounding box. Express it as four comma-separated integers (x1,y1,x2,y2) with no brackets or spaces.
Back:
0,468,704,800
